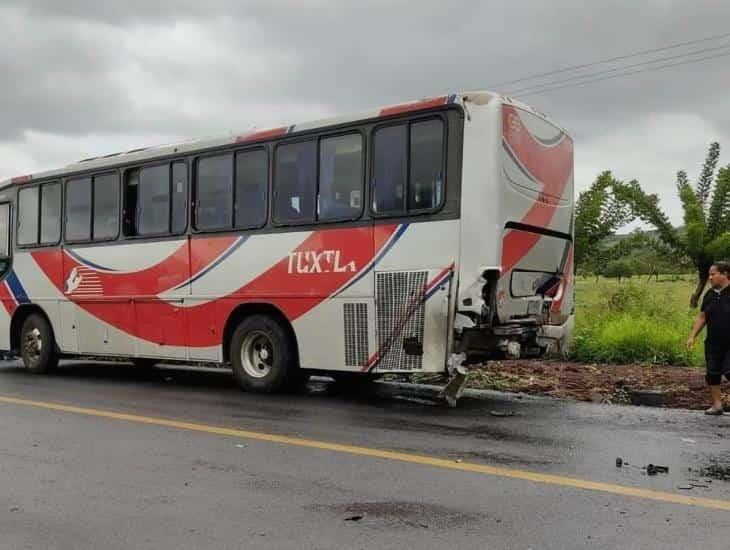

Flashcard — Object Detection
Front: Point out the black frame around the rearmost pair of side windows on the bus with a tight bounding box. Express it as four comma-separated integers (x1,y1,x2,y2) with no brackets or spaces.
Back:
368,110,449,219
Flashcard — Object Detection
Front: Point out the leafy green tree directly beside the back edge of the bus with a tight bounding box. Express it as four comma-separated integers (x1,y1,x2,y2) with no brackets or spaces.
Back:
574,171,632,273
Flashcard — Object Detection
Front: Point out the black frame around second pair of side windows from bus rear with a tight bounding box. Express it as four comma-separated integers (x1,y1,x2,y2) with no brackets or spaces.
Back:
270,126,369,228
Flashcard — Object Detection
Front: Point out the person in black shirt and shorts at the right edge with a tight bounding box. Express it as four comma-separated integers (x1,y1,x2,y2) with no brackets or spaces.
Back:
687,262,730,415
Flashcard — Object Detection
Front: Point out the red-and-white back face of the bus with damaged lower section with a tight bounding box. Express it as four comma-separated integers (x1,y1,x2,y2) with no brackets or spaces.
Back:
497,104,573,322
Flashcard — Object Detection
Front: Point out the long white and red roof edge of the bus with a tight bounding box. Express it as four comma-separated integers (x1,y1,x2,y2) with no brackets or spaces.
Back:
0,90,567,188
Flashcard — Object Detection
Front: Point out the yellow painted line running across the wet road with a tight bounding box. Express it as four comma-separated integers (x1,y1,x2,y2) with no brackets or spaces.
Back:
0,396,730,511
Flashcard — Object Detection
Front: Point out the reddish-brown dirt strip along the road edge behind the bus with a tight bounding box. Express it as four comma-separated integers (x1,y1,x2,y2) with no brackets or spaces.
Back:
458,360,730,409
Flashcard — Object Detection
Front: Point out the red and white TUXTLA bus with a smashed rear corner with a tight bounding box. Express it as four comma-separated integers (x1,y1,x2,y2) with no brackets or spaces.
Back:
0,91,574,398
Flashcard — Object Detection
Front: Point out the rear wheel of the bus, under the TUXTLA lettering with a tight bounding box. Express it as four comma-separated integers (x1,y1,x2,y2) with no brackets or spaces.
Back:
230,315,299,393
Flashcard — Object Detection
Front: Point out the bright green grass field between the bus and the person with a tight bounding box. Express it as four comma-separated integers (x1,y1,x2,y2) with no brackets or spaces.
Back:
571,276,704,366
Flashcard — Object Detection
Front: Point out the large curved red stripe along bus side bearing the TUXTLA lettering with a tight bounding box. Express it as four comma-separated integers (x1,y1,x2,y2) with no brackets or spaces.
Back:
33,225,398,347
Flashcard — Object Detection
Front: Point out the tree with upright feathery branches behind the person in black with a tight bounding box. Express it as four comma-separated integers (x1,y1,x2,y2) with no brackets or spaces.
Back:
613,142,730,308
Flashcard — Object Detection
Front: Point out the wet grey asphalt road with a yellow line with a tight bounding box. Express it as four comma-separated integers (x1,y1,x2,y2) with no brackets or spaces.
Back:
0,363,730,550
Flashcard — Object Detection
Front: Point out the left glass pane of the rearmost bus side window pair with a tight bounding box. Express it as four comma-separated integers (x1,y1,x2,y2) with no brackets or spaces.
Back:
372,124,408,214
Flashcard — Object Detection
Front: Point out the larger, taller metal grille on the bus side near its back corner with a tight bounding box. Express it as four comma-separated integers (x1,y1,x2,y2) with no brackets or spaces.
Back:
375,271,428,371
